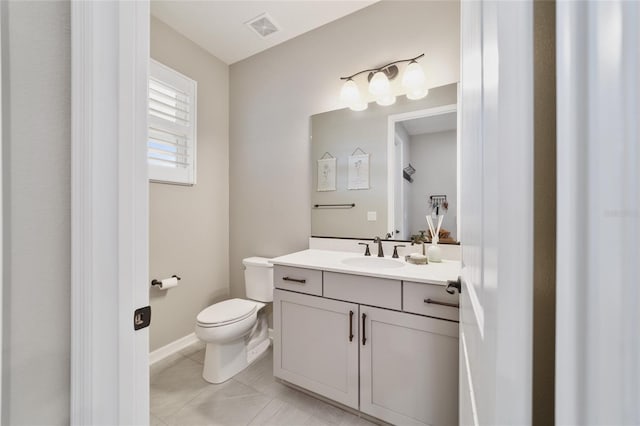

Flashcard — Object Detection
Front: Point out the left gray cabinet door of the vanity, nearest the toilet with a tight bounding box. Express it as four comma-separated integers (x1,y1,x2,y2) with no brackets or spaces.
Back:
273,289,358,409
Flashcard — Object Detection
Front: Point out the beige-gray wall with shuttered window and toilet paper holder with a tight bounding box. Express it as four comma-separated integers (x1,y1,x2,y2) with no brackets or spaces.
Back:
149,18,229,350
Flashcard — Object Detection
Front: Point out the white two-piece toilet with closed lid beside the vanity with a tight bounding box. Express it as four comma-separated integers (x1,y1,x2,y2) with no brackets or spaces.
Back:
196,257,273,383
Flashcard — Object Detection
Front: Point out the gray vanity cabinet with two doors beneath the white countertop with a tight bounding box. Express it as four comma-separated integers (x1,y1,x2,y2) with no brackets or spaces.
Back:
274,265,458,426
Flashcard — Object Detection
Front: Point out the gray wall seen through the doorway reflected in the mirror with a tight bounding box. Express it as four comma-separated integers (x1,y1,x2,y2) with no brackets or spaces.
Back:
409,130,458,240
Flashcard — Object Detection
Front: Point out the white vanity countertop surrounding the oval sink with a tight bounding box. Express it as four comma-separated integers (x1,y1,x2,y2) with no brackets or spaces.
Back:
270,249,460,285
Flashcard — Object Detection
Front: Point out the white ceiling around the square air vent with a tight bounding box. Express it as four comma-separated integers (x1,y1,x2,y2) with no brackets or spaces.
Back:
151,0,377,65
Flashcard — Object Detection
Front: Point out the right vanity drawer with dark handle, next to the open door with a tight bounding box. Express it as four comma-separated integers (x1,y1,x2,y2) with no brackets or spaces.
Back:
402,281,459,321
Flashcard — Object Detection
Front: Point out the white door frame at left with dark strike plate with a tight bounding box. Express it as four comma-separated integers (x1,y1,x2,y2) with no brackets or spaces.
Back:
70,0,150,425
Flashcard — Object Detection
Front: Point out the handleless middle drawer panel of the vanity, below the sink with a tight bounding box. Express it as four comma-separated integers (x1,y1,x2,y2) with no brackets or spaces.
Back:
324,272,402,310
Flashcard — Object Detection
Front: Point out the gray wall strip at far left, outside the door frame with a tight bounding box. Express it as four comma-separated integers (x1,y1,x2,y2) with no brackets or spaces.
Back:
2,1,71,425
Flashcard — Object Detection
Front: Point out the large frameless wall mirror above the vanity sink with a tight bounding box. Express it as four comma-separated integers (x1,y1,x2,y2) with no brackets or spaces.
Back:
311,84,459,243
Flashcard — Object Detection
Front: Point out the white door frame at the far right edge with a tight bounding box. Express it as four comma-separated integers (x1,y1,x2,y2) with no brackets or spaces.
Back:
555,0,640,424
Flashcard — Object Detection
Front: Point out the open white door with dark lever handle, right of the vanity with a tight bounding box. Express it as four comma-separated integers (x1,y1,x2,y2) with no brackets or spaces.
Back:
459,1,533,425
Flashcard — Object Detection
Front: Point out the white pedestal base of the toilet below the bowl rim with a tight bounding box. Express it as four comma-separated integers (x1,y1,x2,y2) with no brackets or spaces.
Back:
202,312,271,384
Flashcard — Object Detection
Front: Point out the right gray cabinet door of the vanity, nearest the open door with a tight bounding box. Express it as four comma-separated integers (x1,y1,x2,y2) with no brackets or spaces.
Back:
358,306,458,426
